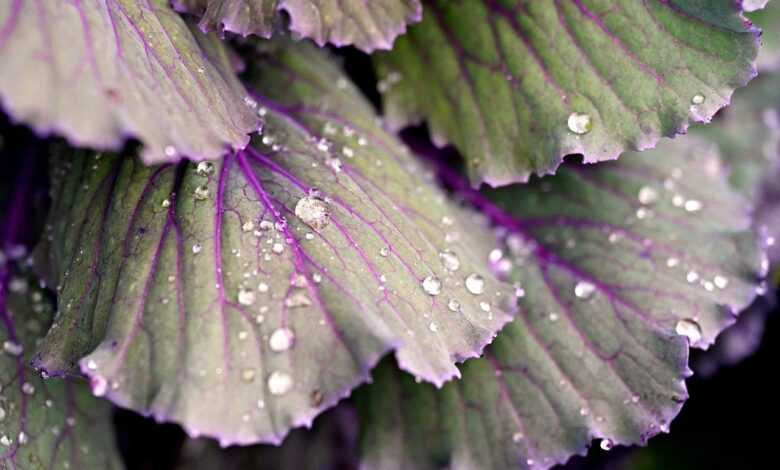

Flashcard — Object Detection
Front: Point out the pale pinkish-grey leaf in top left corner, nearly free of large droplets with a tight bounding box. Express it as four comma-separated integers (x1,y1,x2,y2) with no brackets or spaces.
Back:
0,0,259,163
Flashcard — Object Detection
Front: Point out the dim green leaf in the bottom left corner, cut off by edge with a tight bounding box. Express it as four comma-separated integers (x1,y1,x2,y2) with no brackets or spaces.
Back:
0,268,122,470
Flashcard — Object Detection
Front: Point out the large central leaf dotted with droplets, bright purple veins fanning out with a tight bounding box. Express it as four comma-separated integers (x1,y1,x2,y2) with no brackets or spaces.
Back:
36,44,514,444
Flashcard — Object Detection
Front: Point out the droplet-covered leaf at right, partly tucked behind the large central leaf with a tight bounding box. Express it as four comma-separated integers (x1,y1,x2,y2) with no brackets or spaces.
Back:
356,138,763,469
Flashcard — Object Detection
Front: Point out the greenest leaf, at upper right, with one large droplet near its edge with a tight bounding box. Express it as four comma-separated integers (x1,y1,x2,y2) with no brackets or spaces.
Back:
376,0,758,185
